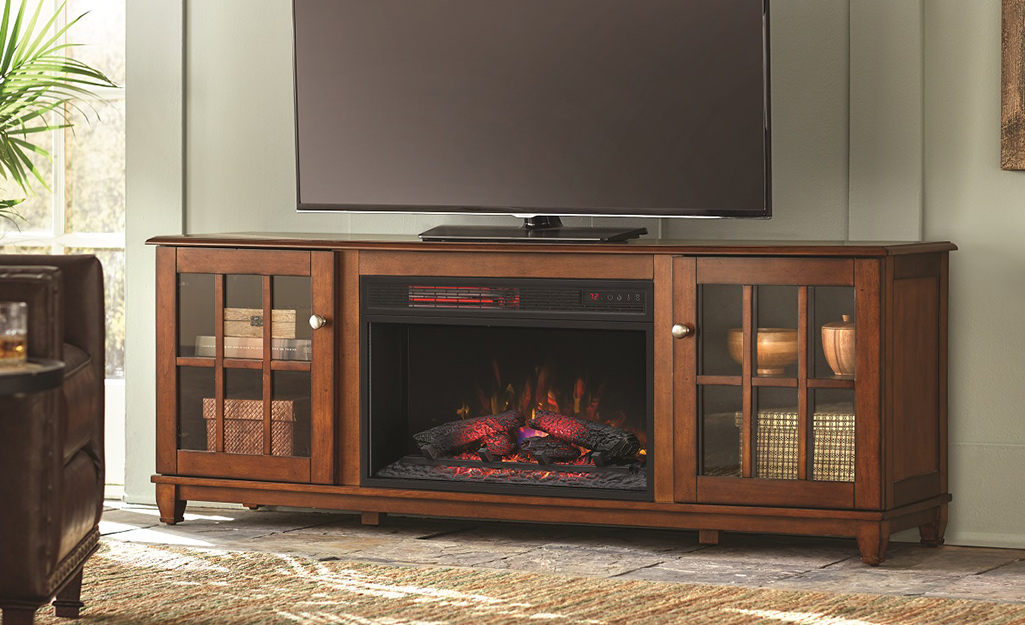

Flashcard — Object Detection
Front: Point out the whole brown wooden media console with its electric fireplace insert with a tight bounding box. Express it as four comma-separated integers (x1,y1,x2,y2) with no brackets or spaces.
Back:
150,234,955,565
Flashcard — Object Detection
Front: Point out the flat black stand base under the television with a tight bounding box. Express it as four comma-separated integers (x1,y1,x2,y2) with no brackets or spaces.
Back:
420,216,648,243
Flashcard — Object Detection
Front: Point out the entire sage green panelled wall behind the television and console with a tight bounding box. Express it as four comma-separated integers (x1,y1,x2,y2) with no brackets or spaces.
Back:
126,0,1025,546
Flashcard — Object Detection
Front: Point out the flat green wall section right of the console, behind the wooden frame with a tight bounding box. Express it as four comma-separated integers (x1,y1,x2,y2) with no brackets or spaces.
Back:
923,0,1025,547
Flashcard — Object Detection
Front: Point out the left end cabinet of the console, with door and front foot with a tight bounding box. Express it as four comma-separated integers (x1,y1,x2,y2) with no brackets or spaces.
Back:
157,247,337,522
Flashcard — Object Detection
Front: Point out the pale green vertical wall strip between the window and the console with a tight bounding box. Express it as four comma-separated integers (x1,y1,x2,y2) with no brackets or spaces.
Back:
125,0,185,502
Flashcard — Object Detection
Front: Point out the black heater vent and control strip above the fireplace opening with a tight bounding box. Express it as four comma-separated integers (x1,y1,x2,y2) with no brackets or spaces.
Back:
364,280,648,315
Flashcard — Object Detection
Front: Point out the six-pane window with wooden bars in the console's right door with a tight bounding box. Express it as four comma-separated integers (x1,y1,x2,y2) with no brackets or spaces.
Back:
697,284,855,483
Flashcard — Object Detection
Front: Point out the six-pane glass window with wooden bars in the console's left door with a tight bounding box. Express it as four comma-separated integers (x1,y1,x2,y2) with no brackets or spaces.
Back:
177,274,313,458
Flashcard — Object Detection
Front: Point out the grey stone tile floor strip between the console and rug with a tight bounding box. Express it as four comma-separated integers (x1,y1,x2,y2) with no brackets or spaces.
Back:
100,501,1025,602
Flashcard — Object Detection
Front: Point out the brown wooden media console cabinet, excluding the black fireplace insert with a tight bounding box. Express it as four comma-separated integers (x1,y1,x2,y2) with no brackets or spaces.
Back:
151,235,954,564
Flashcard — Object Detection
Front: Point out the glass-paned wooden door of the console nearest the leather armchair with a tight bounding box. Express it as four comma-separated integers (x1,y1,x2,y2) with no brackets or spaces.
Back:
161,245,333,482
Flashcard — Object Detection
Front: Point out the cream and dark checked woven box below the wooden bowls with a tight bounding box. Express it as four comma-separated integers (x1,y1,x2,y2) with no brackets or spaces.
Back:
736,410,854,482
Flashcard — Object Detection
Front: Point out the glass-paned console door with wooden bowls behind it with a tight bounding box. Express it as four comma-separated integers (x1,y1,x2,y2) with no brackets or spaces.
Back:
678,255,857,507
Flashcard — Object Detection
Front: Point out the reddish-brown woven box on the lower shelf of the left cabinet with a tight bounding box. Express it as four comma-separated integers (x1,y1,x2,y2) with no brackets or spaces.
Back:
203,398,295,456
